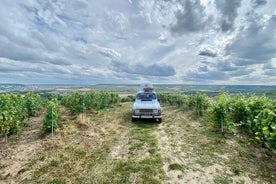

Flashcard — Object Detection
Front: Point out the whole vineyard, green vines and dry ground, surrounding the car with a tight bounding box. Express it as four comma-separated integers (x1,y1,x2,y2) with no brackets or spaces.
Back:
0,90,276,183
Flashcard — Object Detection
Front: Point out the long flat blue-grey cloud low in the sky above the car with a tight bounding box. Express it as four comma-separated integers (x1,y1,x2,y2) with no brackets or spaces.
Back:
112,61,176,76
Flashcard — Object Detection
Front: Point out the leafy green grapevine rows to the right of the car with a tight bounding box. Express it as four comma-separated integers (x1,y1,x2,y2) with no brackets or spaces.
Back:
159,93,276,149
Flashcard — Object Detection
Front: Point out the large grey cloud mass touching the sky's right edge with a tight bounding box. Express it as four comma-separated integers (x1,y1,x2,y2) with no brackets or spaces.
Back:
225,15,276,66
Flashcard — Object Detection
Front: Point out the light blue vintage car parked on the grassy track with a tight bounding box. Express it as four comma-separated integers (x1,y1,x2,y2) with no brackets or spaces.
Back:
131,85,162,123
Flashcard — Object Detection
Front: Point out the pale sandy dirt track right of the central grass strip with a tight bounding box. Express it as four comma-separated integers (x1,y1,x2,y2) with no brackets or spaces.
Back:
155,107,269,184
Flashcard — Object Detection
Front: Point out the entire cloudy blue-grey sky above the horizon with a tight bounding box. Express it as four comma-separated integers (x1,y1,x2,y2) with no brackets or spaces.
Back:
0,0,276,85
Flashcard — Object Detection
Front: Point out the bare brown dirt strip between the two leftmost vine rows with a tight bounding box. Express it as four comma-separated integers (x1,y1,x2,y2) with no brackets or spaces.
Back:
0,112,44,183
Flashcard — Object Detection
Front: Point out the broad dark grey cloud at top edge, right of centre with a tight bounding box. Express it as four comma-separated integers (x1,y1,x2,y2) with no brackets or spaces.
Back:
170,0,207,35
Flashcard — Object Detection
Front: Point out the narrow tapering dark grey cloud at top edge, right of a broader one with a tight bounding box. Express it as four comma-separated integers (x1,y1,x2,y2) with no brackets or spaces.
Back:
215,0,241,32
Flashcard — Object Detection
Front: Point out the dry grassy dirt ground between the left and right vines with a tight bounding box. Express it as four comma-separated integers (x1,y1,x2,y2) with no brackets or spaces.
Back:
0,102,276,184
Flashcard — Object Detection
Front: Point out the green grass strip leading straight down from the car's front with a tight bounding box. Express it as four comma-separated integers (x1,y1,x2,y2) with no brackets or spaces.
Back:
89,122,164,183
